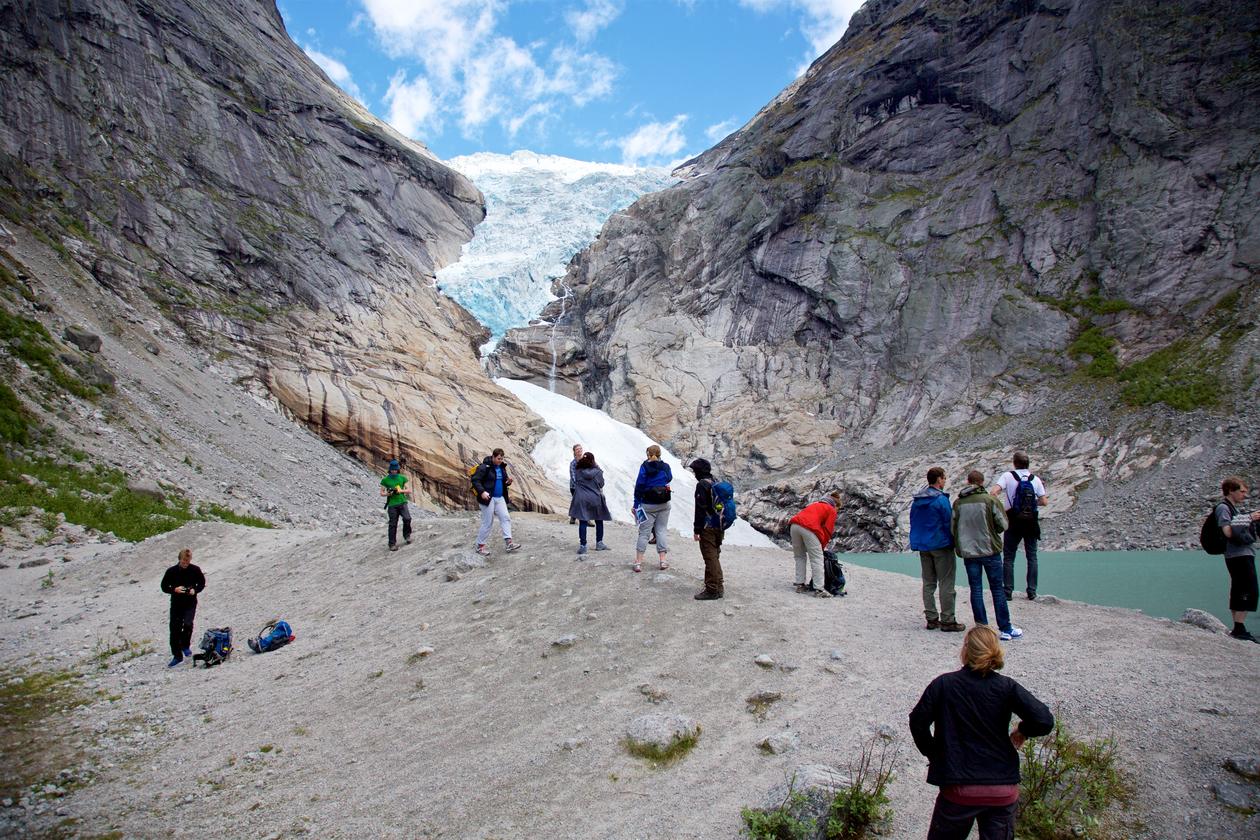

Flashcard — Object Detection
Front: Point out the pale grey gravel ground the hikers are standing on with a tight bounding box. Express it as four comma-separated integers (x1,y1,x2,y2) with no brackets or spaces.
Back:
0,514,1260,840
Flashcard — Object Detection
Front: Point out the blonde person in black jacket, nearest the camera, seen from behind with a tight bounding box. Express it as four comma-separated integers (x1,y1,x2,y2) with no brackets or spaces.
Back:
910,625,1055,840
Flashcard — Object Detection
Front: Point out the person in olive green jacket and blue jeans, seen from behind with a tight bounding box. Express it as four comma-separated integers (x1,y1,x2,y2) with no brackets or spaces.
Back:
950,470,1023,641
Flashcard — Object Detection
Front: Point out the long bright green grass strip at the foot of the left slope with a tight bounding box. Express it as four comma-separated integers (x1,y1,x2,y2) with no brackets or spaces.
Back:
0,455,273,542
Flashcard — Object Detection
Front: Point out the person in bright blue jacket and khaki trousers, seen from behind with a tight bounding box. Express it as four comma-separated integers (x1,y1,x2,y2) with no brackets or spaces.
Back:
910,467,966,632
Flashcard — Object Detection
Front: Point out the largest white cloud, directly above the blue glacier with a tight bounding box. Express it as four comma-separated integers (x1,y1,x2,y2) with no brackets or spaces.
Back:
362,0,620,136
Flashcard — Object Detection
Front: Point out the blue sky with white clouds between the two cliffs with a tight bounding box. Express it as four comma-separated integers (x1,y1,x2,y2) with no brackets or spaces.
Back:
280,0,861,165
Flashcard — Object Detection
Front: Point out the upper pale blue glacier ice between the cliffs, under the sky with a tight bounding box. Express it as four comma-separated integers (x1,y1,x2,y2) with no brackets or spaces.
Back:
437,151,677,345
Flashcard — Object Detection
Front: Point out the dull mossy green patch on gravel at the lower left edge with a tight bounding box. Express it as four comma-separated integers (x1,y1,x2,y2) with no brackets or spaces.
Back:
0,666,91,798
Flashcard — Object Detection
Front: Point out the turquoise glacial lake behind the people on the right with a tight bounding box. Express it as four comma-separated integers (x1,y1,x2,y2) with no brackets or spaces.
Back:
840,550,1234,628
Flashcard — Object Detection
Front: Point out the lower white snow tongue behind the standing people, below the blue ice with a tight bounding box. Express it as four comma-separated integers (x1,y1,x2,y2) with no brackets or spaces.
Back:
494,378,775,548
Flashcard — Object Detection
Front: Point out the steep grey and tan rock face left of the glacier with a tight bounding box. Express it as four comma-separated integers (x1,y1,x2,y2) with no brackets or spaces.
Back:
0,0,557,508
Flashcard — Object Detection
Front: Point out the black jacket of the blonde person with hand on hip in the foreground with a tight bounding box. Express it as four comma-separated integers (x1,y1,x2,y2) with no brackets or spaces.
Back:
910,667,1055,786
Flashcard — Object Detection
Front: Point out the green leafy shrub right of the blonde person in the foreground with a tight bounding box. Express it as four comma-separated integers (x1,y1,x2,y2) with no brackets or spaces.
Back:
1016,723,1130,840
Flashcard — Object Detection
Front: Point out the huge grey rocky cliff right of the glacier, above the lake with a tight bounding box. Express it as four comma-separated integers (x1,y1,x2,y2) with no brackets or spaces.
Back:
499,0,1260,547
